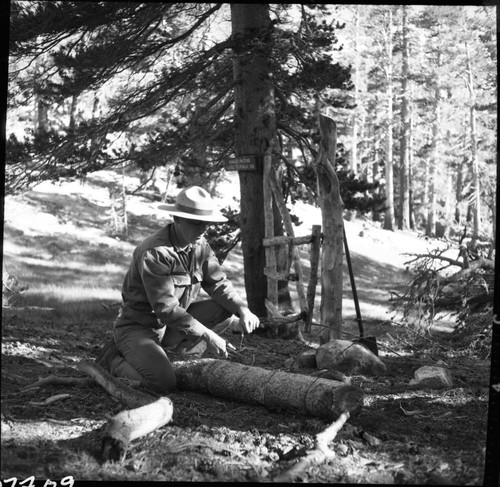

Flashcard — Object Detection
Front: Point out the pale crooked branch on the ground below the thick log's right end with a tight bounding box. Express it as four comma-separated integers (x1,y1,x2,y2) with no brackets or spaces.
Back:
273,412,349,483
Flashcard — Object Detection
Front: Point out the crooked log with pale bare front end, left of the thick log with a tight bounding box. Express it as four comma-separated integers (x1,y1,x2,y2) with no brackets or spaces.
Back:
77,360,174,461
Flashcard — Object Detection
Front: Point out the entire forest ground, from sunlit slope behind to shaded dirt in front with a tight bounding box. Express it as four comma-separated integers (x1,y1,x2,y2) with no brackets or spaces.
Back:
0,173,490,485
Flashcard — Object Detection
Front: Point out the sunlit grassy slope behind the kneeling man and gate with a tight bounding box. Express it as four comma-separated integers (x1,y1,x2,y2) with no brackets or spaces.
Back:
3,172,450,334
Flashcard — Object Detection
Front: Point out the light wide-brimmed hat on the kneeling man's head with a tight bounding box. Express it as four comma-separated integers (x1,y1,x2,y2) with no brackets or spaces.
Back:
159,186,227,223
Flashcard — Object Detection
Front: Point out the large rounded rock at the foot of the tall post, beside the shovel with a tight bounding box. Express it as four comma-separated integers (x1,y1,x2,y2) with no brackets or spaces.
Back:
316,340,387,375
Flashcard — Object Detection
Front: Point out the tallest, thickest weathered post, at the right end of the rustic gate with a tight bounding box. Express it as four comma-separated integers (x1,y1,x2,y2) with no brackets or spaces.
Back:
316,112,343,340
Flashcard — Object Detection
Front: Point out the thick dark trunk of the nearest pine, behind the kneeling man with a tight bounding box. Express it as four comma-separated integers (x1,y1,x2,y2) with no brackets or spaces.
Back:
231,3,276,316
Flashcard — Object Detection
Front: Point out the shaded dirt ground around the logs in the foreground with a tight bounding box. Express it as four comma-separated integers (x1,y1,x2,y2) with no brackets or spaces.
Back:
1,310,489,485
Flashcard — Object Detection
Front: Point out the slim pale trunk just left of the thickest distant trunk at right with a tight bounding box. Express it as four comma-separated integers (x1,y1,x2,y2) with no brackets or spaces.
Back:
384,10,394,230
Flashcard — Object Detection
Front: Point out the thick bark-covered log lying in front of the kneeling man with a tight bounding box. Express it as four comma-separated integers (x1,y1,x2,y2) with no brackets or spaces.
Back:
173,359,364,421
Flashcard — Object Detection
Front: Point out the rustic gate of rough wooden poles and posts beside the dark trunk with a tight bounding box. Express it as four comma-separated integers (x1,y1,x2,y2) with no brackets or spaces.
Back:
263,108,343,340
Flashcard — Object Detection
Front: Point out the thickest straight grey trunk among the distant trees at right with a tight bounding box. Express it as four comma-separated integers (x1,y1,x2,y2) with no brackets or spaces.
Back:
399,5,410,230
